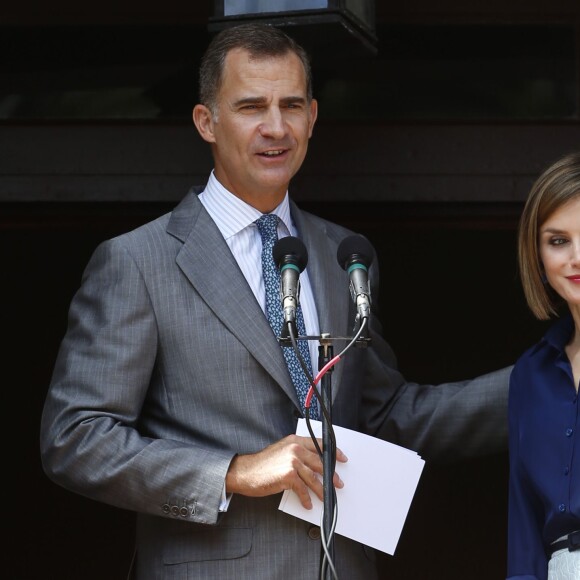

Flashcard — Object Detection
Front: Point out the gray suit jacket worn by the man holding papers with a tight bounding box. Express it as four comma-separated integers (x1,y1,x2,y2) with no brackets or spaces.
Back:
41,190,510,580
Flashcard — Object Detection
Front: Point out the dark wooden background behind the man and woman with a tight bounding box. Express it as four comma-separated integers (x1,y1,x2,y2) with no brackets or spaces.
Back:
0,0,580,580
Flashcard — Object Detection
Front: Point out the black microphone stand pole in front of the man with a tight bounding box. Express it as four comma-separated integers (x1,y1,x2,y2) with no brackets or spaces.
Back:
318,333,336,580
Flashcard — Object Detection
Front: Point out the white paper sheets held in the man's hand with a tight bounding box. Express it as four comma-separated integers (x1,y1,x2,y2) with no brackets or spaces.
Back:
279,419,425,555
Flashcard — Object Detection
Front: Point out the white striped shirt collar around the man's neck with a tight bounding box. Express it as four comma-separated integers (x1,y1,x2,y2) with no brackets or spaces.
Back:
199,171,294,240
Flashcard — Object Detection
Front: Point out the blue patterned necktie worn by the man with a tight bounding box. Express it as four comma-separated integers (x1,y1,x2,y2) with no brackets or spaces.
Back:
256,213,319,419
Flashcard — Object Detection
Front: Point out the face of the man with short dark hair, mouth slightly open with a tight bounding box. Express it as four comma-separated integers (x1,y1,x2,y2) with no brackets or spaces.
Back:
193,49,317,212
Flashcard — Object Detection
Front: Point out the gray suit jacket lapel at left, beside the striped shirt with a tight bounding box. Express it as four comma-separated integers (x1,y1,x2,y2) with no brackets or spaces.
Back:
167,193,298,406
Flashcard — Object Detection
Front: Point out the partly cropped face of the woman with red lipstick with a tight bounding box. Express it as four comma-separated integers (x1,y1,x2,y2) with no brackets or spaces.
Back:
539,196,580,312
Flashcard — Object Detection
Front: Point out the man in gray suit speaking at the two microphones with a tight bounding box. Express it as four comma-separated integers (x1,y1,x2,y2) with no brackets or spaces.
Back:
41,24,510,580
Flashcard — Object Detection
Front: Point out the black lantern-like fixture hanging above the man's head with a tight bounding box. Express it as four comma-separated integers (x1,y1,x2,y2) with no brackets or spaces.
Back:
208,0,378,57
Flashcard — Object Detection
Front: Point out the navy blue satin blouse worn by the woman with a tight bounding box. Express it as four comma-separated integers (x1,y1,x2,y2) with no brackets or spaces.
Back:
507,315,580,580
